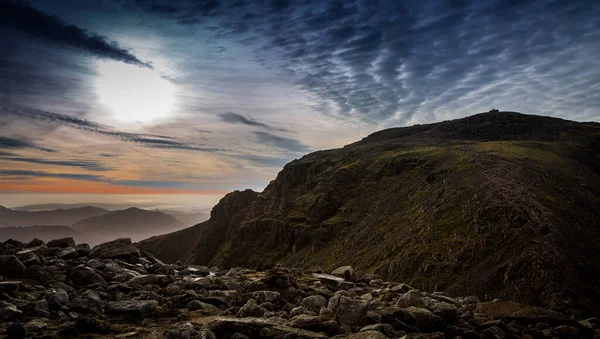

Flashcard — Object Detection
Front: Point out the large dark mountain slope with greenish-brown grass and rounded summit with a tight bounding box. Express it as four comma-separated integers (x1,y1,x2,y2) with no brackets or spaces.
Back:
139,112,600,314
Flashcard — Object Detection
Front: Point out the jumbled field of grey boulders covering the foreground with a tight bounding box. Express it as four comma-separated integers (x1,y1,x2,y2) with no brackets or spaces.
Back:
0,238,600,339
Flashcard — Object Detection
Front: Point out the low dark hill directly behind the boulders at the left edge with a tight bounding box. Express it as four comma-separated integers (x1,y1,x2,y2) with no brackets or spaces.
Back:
0,226,98,244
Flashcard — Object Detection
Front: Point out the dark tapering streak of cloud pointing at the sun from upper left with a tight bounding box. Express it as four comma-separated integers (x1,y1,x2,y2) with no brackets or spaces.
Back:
0,0,152,68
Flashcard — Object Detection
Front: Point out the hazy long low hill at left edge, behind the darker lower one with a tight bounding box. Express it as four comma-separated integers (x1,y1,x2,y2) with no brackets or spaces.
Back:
0,206,109,228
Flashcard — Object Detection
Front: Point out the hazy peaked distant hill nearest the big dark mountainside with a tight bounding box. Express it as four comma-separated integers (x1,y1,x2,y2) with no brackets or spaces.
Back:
73,207,186,246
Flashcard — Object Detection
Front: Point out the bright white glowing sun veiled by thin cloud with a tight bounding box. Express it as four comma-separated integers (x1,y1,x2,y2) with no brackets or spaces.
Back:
95,61,175,123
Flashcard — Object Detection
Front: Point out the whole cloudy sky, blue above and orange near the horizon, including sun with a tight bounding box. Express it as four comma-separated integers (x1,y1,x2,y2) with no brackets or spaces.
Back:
0,0,600,203
